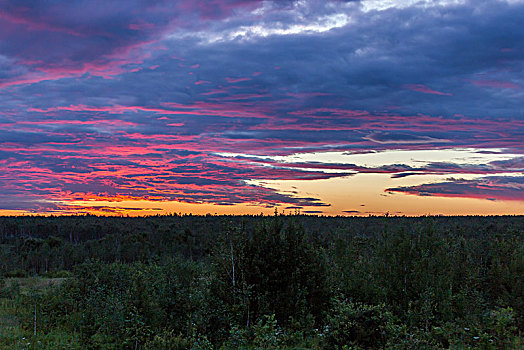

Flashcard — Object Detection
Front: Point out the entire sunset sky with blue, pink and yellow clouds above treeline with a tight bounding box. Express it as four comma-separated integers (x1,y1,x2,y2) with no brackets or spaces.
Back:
0,0,524,216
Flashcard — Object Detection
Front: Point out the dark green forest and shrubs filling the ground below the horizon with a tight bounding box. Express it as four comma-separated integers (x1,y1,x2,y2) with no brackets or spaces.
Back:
0,215,524,349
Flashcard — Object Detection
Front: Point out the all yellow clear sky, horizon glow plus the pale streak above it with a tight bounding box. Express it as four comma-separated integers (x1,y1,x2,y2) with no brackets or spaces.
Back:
0,149,524,216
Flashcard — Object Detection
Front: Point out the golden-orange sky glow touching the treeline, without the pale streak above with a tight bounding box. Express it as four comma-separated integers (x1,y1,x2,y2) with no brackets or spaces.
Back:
0,174,524,216
